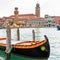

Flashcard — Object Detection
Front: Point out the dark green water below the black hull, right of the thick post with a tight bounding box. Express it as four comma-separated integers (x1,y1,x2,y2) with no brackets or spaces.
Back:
11,54,48,60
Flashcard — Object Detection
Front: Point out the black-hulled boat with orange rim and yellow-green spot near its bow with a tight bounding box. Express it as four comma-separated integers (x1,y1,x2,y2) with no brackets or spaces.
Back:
0,35,50,58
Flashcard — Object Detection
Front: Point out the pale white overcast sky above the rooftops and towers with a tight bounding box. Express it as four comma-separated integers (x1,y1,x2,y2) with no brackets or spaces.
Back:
0,0,60,17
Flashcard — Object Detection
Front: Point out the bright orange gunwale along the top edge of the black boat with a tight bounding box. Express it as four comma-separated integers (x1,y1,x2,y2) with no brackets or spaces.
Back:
0,39,47,49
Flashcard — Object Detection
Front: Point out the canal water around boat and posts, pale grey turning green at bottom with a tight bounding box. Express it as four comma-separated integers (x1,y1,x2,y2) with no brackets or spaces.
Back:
0,28,60,60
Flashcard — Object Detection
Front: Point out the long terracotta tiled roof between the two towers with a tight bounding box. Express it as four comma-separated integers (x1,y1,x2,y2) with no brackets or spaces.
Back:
5,14,44,20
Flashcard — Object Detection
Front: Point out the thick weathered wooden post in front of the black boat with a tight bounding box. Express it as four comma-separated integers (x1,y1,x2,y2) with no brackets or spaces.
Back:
6,22,11,60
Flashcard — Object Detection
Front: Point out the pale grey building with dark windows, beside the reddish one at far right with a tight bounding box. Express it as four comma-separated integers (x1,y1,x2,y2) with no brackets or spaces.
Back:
44,15,56,27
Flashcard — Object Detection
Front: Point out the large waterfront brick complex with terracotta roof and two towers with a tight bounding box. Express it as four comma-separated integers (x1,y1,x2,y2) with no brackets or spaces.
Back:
0,3,44,27
